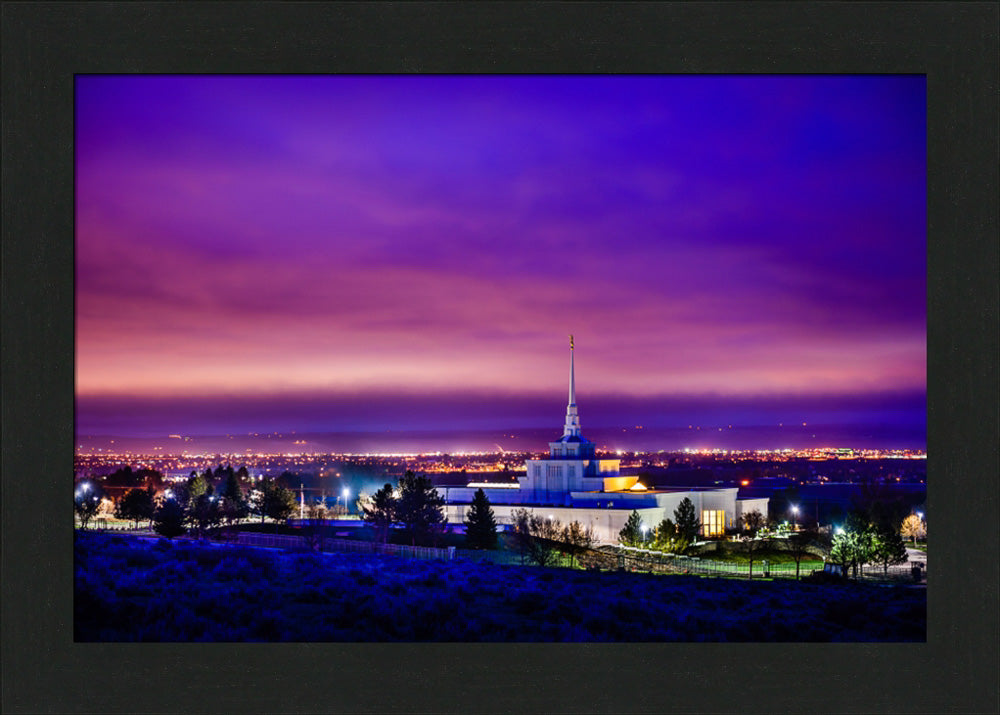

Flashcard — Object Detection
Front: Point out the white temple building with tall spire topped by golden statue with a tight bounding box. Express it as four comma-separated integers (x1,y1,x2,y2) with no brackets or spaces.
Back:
438,336,768,543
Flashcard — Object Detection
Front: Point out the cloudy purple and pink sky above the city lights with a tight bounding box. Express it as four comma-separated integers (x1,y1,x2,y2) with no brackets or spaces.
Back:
76,76,926,434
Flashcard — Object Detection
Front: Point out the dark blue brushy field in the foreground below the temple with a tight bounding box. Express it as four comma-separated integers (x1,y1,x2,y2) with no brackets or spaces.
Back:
74,532,926,642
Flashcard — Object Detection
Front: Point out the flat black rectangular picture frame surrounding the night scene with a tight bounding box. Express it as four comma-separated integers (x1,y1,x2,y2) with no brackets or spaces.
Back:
0,2,1000,713
